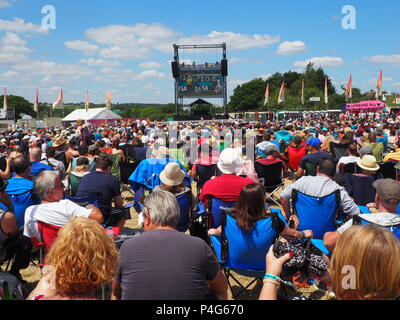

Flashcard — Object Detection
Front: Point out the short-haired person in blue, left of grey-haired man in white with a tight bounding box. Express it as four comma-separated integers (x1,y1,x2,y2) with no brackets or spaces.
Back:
6,156,40,229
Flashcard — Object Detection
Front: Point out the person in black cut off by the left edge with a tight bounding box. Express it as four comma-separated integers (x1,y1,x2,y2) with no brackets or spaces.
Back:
0,180,32,282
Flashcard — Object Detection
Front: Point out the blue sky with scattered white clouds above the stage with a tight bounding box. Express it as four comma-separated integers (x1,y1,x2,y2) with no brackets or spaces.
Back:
0,0,400,103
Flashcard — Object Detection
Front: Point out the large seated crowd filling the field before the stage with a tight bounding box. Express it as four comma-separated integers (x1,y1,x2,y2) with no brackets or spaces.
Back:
0,110,400,300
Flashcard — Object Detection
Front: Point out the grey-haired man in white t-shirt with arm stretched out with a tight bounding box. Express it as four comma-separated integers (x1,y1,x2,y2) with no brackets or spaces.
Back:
24,171,104,239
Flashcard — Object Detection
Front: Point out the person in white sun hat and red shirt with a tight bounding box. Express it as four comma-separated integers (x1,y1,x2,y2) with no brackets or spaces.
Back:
199,148,254,205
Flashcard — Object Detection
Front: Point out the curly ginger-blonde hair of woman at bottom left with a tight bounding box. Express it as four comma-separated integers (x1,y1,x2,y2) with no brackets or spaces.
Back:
46,217,119,294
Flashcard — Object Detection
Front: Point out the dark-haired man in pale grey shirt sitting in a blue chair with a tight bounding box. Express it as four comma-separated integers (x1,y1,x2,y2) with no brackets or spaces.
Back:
281,159,360,222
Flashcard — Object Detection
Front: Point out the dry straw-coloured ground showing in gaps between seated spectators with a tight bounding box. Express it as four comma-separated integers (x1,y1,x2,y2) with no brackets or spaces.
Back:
2,180,330,300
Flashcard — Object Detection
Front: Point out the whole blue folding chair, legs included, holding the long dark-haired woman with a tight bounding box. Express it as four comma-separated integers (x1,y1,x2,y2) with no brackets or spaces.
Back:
210,209,286,299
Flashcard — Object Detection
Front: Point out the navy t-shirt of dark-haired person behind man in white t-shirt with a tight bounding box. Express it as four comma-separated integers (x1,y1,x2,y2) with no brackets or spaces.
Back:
76,171,121,206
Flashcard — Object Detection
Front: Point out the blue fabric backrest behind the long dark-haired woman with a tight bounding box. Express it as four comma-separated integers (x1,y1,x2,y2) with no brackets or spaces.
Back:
217,211,284,271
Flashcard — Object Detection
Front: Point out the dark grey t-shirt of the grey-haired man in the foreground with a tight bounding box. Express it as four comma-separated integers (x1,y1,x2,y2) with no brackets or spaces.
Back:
116,229,220,300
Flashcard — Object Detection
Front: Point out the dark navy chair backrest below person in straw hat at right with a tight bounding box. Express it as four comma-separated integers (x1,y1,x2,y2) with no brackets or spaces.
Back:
344,173,378,206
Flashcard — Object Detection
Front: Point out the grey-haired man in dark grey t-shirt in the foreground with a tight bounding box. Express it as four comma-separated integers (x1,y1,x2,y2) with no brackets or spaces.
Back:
112,191,227,300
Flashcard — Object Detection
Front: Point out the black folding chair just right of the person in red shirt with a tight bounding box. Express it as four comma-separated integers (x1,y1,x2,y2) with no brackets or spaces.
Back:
254,161,285,206
